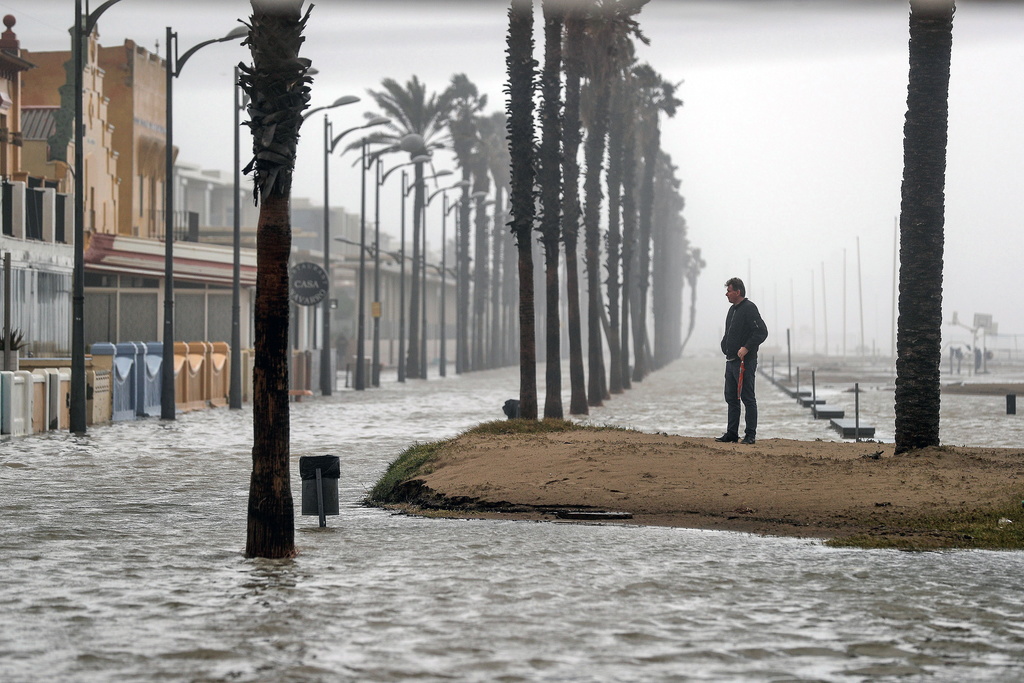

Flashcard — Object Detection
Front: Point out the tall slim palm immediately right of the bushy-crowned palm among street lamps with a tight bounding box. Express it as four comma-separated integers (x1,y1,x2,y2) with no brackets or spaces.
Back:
449,74,487,373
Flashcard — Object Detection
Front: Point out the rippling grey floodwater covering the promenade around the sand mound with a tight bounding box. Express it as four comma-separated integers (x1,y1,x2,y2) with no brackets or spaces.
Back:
0,358,1024,682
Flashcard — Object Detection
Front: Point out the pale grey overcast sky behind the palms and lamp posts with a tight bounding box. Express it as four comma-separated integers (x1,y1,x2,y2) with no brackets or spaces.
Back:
8,0,1024,358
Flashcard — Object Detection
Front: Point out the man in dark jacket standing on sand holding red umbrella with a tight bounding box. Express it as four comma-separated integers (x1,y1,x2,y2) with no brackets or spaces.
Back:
715,278,768,443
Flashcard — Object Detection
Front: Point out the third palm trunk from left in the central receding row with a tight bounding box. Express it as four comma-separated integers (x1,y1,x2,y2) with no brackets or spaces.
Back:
562,3,590,415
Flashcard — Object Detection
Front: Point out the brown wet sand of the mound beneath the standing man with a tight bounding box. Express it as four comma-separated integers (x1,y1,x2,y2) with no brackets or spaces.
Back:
389,430,1024,538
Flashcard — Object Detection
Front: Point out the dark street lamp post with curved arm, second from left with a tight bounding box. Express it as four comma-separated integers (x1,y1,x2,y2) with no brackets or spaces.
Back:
160,27,249,420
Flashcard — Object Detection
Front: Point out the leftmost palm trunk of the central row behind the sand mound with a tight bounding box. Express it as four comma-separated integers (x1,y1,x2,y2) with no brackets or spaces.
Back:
505,0,537,420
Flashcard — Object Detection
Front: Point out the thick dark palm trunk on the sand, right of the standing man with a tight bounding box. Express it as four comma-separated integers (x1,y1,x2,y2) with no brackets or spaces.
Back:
896,0,954,454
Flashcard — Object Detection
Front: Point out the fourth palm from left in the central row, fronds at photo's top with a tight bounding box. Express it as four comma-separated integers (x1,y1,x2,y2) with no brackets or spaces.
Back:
584,0,648,405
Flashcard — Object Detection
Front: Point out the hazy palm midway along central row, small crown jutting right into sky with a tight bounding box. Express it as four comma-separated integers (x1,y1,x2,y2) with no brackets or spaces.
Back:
633,65,682,382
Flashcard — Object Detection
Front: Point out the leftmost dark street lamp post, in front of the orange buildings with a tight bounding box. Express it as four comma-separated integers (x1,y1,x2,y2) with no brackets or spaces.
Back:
69,0,120,434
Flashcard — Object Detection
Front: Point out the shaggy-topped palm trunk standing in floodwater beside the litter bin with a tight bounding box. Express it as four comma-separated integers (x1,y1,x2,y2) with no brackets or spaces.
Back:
239,0,312,558
